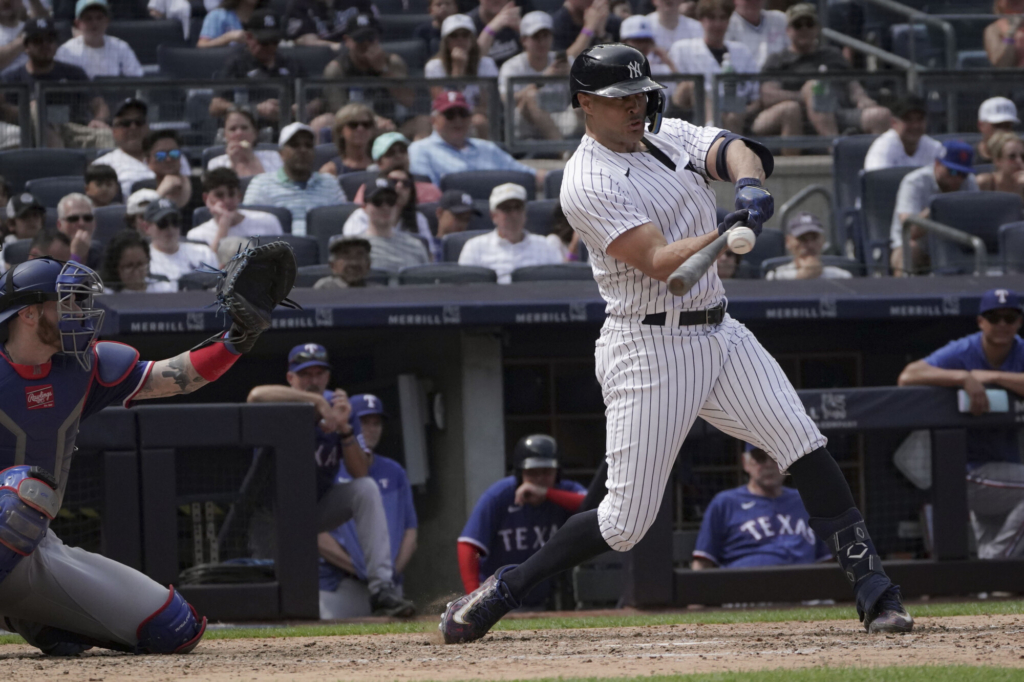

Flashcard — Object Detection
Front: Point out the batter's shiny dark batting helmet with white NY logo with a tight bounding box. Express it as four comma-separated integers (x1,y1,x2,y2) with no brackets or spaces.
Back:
569,43,666,132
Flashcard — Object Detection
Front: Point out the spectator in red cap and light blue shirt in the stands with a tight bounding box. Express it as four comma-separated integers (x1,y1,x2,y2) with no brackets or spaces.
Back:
409,90,544,187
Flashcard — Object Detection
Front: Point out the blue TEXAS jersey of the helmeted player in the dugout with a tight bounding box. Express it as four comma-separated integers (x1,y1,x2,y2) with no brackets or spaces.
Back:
459,476,587,605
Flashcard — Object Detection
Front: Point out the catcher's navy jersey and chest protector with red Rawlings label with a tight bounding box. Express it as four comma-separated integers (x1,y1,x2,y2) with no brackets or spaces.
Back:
0,341,153,497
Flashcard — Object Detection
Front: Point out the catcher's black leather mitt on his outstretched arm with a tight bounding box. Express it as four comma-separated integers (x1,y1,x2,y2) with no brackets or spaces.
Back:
204,237,300,352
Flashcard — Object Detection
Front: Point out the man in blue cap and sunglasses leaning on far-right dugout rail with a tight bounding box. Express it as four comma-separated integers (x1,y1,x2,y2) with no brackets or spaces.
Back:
899,289,1024,559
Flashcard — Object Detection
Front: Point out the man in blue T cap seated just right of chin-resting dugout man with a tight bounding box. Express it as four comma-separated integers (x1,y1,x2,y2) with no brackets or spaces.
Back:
316,393,418,620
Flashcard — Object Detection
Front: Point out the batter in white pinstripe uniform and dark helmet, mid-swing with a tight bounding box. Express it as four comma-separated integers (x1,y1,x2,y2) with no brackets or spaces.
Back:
440,44,913,643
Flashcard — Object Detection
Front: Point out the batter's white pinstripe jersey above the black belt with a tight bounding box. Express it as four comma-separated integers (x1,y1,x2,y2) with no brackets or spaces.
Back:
559,119,725,317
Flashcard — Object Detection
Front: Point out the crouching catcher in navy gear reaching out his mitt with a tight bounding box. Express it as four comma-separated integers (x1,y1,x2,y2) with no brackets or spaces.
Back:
0,242,296,655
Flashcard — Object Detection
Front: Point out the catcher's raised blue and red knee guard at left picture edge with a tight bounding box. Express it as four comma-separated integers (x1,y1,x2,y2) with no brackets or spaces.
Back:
0,465,60,582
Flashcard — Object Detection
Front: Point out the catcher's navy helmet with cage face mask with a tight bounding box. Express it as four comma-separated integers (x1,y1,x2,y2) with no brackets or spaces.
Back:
0,258,105,370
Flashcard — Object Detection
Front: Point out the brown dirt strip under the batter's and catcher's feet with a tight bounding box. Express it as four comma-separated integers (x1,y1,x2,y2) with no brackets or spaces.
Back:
0,615,1024,682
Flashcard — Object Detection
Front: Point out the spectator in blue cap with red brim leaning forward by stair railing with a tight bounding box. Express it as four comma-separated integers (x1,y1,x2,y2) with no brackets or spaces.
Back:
889,139,978,276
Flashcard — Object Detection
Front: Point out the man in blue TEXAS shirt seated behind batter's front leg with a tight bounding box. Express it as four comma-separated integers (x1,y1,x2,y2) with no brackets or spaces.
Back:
691,443,831,570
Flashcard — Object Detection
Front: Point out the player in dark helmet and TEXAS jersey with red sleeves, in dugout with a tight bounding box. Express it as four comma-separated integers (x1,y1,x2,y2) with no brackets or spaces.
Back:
459,434,587,610
